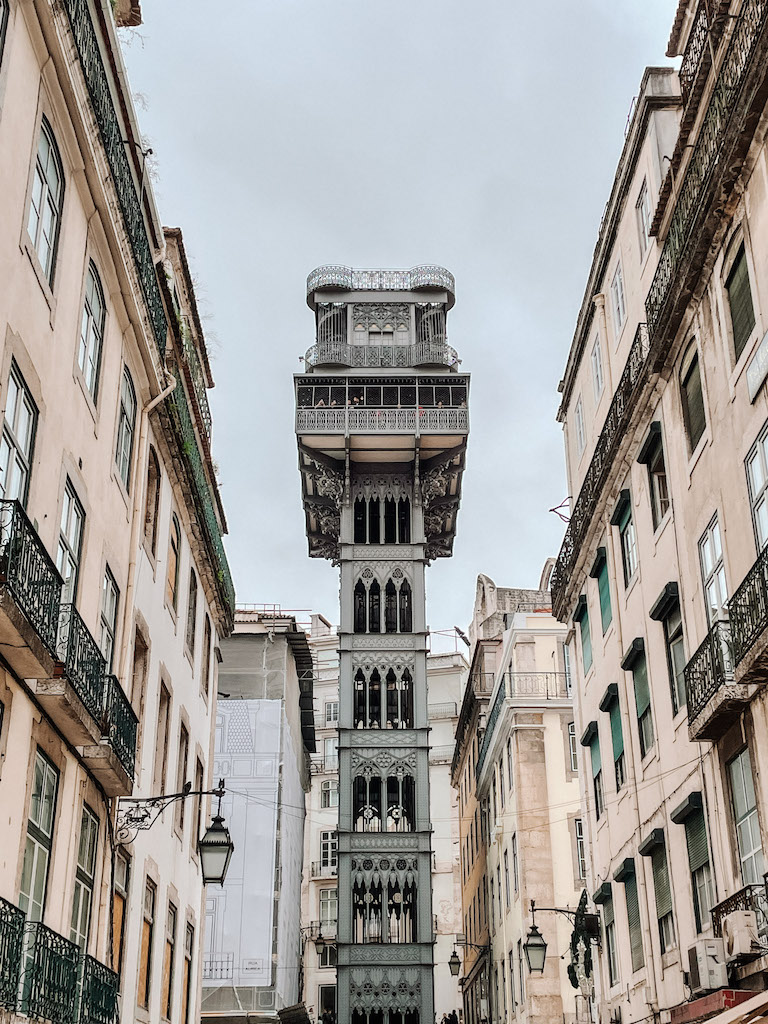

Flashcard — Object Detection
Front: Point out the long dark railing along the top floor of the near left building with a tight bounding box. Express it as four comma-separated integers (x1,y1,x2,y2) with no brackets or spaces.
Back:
61,0,168,358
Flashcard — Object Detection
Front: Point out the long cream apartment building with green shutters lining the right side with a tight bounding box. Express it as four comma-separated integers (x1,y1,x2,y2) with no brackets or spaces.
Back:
552,6,768,1024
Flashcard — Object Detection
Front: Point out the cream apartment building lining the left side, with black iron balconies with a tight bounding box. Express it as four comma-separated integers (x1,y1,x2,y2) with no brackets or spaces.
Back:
0,0,233,1024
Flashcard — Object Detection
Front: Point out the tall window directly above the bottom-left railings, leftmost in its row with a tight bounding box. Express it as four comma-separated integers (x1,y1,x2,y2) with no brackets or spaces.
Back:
18,751,58,921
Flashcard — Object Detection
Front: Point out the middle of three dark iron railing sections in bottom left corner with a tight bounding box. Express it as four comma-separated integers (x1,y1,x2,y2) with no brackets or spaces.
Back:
19,922,80,1024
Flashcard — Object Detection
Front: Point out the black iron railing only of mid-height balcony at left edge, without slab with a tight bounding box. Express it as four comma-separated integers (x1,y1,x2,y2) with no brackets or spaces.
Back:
0,501,62,656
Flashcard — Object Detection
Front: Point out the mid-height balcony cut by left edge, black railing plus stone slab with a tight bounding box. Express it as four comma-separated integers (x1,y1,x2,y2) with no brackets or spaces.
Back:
0,501,62,679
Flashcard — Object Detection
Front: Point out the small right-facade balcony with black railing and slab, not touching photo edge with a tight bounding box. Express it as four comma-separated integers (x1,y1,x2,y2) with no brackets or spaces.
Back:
685,620,755,740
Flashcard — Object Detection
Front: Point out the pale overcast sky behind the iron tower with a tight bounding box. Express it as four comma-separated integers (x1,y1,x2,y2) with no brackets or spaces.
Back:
121,0,676,629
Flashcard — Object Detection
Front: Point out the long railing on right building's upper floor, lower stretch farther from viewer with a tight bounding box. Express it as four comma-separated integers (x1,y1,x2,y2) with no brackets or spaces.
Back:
550,324,648,620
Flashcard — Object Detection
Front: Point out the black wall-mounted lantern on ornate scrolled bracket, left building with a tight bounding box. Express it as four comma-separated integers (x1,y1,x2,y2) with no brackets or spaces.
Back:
115,778,234,886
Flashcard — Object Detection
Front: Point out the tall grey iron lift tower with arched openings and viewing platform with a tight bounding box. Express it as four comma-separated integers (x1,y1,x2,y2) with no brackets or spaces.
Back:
295,266,469,1024
